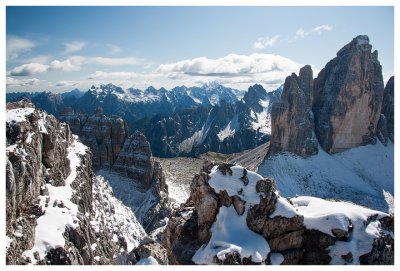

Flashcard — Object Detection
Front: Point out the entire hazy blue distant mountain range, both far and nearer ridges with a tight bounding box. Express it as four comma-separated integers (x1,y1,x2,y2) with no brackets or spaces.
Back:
6,83,282,157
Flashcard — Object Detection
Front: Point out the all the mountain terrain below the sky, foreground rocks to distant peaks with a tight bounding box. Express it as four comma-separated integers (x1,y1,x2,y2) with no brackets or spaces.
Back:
6,35,395,265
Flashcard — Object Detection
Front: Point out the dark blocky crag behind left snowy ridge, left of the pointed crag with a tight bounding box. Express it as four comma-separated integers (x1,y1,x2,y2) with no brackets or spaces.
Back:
60,107,129,169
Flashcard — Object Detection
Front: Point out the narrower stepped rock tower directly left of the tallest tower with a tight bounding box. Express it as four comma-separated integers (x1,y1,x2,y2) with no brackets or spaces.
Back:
269,65,318,156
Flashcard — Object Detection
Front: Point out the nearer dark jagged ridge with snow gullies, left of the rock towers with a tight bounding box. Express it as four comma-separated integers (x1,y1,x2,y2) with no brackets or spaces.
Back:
135,84,282,157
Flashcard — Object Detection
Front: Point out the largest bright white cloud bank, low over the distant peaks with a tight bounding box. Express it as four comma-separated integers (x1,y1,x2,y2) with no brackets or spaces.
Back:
156,54,302,89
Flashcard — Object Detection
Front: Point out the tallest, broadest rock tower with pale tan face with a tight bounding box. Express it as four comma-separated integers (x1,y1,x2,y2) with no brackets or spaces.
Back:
313,36,384,153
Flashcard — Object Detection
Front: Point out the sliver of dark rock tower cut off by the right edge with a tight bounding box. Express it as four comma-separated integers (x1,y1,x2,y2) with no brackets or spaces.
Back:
377,76,394,145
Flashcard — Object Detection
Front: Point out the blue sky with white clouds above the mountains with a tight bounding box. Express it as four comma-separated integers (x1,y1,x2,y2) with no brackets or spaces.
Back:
6,7,394,92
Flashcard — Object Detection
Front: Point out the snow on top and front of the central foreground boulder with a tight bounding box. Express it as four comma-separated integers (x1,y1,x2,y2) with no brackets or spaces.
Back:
192,166,270,264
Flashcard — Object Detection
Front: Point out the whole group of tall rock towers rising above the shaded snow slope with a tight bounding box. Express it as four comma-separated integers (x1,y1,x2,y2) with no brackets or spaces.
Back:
268,36,394,157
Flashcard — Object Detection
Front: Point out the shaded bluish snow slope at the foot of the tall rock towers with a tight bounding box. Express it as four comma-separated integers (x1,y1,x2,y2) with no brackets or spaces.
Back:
258,140,394,215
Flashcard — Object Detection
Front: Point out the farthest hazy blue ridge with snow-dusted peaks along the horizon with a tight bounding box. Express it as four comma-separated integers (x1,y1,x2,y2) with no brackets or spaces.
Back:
6,83,244,123
